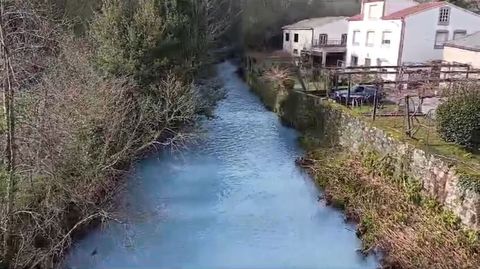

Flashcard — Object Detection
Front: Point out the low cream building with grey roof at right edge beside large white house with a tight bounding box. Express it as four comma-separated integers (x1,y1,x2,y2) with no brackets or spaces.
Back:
443,31,480,69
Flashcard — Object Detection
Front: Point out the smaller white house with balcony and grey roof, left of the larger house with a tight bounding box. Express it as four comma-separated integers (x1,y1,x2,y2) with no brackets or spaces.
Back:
282,17,348,65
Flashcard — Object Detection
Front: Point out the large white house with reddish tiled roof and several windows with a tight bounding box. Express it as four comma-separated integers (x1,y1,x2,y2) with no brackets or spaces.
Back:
346,0,480,66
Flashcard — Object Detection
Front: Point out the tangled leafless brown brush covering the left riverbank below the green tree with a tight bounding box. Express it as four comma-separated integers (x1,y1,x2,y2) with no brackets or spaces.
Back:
0,37,203,268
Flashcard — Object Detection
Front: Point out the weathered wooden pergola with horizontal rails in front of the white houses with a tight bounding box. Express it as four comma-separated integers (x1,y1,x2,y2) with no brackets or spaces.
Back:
299,61,480,118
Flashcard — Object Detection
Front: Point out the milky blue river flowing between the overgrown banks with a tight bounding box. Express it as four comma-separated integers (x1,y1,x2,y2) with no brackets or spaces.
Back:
66,62,377,269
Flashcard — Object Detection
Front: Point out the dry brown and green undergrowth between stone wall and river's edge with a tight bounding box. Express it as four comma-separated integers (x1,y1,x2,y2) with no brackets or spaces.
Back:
308,148,480,269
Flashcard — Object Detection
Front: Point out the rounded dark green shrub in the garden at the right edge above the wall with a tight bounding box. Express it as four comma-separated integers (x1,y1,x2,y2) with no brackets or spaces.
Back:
436,88,480,150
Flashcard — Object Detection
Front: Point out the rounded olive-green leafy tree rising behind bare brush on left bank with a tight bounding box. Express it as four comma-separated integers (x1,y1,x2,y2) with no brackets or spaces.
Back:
90,0,170,85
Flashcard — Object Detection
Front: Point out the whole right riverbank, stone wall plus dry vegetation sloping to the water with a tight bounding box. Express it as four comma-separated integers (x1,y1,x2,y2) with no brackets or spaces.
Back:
247,59,480,269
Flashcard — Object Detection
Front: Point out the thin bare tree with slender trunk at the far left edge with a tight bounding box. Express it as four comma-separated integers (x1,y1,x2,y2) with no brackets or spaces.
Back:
0,0,57,262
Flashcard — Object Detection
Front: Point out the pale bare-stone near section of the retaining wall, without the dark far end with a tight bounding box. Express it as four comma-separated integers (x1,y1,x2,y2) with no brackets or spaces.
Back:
336,108,480,230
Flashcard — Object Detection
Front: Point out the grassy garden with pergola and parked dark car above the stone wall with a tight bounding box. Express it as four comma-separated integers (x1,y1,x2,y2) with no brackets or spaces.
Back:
246,51,480,174
